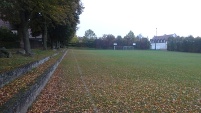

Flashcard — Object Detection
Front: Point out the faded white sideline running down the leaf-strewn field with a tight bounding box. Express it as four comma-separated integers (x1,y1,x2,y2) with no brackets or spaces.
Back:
71,50,98,113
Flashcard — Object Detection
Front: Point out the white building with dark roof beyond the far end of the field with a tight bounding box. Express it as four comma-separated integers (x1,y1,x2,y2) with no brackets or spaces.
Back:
150,34,176,50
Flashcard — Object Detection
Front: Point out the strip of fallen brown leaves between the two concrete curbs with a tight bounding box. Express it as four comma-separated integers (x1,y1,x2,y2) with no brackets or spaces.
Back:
0,52,62,106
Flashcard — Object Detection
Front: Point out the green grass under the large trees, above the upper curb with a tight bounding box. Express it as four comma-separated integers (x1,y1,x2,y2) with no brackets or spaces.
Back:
0,49,59,73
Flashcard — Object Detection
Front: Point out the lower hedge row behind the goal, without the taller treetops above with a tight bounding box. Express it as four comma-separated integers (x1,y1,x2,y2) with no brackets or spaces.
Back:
70,35,150,49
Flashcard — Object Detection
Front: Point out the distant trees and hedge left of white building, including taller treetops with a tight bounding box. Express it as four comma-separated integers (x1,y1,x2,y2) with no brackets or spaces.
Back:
70,29,150,49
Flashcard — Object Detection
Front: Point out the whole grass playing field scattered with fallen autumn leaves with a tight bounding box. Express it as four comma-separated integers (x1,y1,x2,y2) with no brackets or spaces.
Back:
29,50,201,113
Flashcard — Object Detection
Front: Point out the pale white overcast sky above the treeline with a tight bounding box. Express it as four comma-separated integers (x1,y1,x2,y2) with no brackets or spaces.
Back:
77,0,201,39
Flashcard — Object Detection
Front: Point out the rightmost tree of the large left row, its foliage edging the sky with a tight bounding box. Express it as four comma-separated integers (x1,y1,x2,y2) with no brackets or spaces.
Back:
48,0,83,48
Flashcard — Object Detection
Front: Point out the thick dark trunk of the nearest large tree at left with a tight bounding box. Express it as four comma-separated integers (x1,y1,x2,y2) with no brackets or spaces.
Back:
19,12,31,55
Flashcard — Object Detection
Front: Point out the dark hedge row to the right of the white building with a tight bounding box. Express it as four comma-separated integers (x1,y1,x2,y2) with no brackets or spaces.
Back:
167,36,201,53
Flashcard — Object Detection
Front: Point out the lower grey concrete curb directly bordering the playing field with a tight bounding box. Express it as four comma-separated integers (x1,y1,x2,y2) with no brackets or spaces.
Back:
0,50,67,113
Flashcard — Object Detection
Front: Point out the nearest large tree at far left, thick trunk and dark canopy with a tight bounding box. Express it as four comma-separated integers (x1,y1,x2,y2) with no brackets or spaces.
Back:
0,0,37,54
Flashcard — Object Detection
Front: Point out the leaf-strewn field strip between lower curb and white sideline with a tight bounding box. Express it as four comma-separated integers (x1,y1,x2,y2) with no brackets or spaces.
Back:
28,50,96,113
